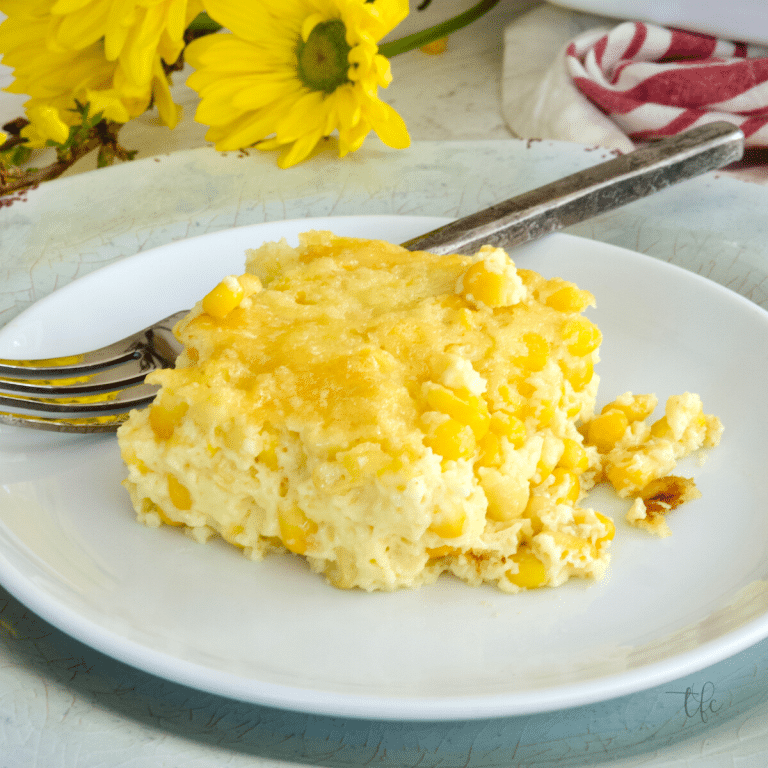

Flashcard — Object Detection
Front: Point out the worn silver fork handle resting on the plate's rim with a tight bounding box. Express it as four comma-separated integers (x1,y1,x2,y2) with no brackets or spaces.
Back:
402,121,744,254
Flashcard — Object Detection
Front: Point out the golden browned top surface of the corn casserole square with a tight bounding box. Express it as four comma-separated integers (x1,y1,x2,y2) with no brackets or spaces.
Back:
148,232,600,457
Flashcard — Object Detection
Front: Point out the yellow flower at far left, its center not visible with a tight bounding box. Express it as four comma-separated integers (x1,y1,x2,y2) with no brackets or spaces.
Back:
0,0,202,147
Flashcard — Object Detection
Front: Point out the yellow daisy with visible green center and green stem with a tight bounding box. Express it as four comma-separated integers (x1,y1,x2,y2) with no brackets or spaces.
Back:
185,0,410,168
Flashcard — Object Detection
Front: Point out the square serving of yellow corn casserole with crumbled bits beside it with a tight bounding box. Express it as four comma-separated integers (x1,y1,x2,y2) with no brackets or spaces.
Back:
118,232,722,592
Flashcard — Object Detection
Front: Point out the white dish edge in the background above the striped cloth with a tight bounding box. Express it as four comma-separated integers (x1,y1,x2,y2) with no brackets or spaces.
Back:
550,0,768,45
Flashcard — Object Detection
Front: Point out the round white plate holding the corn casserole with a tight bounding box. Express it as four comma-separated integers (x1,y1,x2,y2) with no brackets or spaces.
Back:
0,216,768,719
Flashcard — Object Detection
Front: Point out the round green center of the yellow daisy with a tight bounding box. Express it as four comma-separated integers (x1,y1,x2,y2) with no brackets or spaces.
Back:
296,19,352,93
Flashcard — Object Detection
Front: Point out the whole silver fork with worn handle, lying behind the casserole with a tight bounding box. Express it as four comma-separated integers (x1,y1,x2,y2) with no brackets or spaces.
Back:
0,122,744,433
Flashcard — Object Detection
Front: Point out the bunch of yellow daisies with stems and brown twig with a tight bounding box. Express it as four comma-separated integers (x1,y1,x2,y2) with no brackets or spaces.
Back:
0,0,498,194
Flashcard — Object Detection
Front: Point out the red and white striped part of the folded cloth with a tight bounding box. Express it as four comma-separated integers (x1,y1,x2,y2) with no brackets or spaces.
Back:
566,22,768,147
